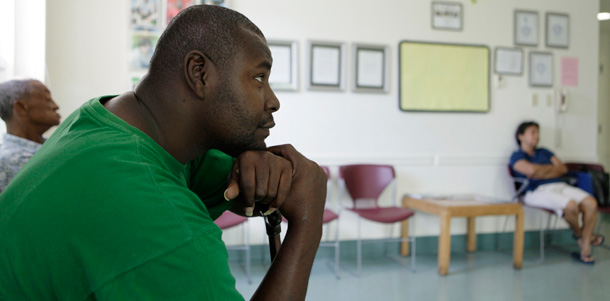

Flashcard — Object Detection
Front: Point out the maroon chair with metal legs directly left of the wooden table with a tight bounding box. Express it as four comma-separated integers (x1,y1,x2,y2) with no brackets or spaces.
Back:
339,164,415,273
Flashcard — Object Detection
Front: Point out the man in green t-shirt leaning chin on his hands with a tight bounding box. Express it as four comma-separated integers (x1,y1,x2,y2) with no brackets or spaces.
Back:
0,6,326,300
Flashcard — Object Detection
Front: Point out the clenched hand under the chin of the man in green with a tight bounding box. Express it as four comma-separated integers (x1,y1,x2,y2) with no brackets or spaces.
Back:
225,151,293,216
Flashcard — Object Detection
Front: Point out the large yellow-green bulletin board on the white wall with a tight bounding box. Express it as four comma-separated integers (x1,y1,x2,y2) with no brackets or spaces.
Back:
399,41,490,112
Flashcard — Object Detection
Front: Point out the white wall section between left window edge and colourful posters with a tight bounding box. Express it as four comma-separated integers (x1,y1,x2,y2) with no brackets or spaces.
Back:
46,0,130,121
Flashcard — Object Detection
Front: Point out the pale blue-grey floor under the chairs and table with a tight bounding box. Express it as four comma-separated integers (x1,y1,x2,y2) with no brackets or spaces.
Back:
231,232,610,301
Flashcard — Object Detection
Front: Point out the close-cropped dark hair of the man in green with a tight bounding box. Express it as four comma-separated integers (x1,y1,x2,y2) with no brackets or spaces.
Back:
149,5,264,78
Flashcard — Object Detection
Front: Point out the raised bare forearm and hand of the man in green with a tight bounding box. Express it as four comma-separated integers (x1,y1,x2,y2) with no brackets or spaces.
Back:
252,145,327,300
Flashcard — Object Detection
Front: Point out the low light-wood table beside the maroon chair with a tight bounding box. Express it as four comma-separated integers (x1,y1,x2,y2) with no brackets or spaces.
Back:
400,196,524,275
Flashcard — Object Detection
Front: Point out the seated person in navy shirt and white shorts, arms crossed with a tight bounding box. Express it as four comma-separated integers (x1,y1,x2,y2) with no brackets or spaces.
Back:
510,121,604,264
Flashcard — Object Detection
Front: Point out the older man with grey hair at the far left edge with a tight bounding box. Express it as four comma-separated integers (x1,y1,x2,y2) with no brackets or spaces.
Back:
0,79,60,192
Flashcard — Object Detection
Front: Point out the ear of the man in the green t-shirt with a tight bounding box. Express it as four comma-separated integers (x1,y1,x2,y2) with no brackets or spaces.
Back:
184,50,212,99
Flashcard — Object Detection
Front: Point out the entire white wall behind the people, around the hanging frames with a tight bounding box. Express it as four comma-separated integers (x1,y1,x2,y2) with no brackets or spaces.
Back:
47,0,599,243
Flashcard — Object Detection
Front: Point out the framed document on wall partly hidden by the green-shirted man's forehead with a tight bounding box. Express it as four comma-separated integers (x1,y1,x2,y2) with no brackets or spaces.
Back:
267,40,299,91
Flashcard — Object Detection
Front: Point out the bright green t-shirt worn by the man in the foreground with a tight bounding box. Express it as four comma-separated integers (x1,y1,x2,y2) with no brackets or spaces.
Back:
0,96,243,300
